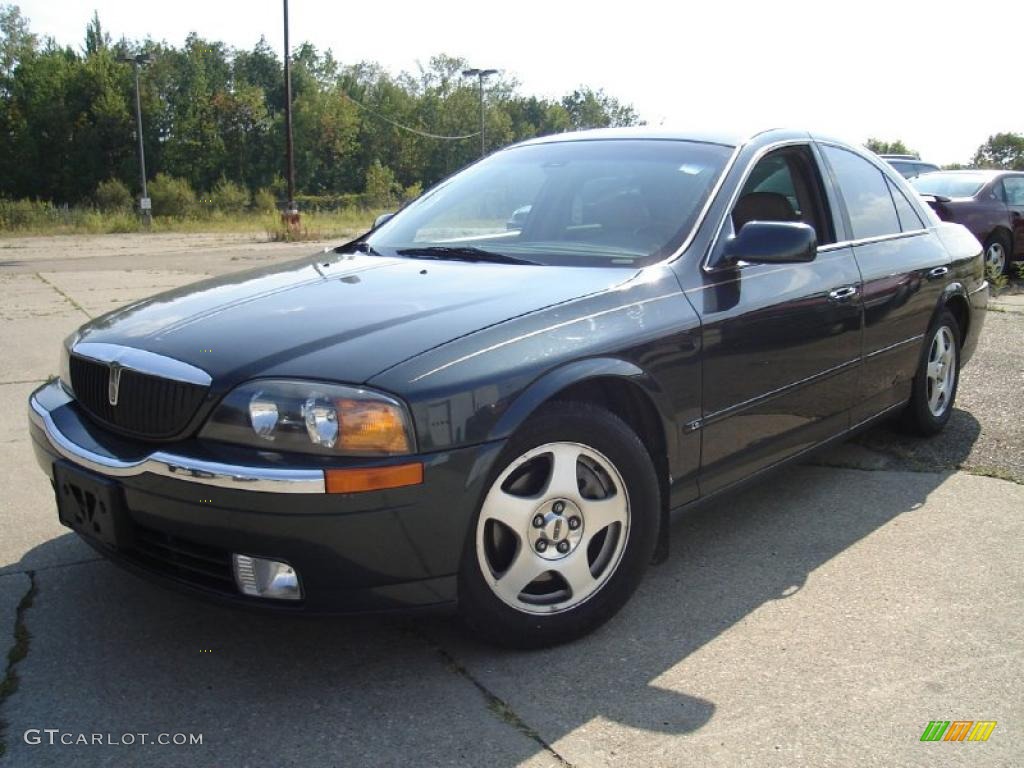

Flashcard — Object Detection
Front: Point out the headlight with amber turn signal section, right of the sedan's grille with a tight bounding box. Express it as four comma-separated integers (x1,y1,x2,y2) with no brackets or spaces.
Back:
200,379,415,456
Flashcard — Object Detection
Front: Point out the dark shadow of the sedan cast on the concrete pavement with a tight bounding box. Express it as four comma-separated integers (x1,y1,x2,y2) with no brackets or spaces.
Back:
3,448,974,766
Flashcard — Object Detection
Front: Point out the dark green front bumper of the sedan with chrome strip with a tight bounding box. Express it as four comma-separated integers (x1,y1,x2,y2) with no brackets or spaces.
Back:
29,381,503,613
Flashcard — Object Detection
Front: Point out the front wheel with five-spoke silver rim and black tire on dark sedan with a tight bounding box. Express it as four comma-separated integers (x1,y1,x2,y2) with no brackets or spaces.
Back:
459,402,659,648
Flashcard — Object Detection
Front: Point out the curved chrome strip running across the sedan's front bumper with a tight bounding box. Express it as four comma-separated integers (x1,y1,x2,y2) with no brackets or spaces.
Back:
29,395,326,494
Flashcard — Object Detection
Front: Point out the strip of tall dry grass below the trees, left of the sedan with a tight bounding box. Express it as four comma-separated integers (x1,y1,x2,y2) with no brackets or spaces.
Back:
0,199,383,240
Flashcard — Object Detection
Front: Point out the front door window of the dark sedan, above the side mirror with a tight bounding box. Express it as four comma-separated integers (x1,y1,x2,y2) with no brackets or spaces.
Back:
732,147,835,245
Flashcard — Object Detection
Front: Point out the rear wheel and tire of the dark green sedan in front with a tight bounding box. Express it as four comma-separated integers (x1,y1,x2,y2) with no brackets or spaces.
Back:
903,309,961,437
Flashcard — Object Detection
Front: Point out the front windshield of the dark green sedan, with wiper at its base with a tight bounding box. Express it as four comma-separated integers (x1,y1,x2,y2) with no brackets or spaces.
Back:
366,139,731,266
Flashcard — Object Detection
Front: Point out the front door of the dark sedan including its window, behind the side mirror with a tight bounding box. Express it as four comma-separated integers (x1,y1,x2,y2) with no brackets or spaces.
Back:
687,142,861,495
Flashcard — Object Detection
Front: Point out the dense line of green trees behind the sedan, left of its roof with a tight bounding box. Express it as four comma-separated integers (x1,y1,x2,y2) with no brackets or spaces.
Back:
0,10,639,204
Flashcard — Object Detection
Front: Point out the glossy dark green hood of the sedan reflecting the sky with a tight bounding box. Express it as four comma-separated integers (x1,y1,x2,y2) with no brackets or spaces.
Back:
80,253,634,389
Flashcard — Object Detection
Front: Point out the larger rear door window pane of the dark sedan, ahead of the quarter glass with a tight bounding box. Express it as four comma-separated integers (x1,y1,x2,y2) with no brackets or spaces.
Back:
821,145,902,240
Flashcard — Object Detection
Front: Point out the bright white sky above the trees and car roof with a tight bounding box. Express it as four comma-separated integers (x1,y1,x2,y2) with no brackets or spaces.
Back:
14,0,1024,163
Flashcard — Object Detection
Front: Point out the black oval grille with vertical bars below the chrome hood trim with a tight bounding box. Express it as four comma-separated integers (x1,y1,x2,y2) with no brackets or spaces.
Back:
71,354,207,439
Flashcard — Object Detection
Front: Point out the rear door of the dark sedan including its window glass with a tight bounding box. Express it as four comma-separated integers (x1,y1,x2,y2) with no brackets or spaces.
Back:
819,143,949,425
